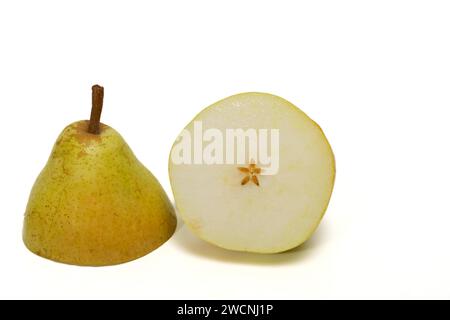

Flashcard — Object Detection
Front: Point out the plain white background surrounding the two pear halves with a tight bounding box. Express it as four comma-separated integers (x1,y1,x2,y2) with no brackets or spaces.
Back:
0,0,450,299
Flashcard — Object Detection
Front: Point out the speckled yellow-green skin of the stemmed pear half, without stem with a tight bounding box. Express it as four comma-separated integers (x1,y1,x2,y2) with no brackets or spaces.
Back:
23,121,176,266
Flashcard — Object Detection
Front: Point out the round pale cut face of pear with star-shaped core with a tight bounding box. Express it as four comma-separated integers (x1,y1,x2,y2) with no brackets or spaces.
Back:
169,93,335,253
